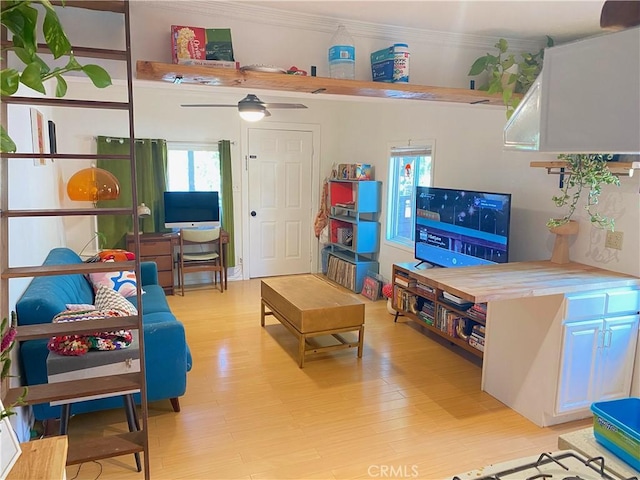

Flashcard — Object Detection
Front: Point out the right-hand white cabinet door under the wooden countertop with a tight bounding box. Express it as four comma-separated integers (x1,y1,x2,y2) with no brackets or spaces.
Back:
594,315,638,401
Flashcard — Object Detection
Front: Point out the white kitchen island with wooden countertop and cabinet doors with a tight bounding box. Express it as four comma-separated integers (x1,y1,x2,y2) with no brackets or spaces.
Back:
412,261,640,427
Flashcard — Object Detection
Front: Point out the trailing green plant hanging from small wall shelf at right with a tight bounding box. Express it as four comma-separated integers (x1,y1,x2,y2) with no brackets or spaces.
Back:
547,153,620,231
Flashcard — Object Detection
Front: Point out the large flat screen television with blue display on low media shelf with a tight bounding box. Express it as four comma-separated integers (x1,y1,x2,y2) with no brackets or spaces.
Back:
414,187,511,267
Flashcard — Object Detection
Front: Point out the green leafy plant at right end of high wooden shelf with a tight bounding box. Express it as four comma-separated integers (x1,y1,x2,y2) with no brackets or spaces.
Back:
468,36,554,119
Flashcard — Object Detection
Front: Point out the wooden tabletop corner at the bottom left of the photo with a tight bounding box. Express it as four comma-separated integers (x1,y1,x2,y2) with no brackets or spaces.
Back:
7,435,67,480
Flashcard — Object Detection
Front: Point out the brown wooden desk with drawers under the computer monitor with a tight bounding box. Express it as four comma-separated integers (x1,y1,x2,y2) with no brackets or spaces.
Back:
127,229,229,295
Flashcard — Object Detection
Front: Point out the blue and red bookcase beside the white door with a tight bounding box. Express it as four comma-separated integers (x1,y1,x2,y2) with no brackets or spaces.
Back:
326,179,381,292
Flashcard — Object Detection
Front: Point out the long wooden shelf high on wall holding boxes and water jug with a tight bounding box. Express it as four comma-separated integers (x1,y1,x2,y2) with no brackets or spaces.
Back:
136,60,504,106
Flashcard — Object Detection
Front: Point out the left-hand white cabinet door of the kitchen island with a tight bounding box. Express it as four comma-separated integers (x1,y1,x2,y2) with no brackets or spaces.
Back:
556,319,603,413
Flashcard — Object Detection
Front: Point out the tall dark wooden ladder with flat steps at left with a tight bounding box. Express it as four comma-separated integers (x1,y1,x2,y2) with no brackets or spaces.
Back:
0,0,150,479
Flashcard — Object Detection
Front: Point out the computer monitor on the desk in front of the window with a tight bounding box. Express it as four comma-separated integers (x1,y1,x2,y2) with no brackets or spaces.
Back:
164,192,220,228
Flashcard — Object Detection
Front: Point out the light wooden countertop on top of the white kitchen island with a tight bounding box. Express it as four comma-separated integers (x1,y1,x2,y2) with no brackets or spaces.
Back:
398,260,640,303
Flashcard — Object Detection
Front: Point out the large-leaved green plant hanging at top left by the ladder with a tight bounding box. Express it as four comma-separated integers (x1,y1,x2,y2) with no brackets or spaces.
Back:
0,0,111,152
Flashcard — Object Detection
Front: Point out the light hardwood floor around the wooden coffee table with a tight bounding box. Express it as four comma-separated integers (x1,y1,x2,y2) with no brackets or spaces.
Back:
67,280,590,479
